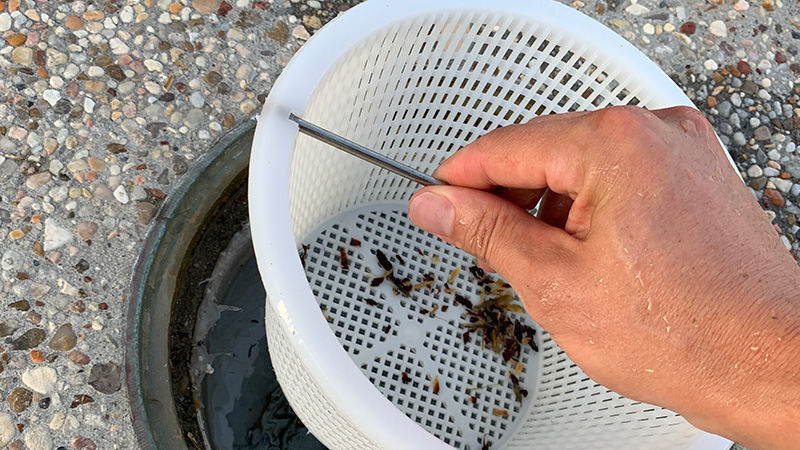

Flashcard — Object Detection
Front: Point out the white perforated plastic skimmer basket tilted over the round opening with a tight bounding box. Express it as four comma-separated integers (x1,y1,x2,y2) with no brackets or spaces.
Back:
250,0,730,450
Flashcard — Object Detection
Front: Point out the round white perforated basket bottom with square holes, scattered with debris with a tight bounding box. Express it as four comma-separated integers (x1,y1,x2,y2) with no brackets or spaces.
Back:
304,204,539,449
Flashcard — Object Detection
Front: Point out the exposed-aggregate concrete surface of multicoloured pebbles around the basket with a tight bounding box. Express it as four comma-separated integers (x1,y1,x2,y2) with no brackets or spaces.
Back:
0,0,800,450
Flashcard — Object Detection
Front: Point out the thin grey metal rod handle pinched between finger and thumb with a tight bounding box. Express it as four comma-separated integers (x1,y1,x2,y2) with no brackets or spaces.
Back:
289,114,447,186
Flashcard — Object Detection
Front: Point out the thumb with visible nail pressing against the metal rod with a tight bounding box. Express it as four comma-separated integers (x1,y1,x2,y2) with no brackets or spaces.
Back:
408,186,575,285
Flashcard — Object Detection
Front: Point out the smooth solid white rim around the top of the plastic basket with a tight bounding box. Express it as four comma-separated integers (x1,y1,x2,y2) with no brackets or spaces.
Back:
248,0,730,450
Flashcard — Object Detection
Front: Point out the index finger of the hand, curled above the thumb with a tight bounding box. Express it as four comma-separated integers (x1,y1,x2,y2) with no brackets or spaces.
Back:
435,107,663,199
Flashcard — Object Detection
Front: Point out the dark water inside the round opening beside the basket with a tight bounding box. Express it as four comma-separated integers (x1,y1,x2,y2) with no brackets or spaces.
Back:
202,258,325,450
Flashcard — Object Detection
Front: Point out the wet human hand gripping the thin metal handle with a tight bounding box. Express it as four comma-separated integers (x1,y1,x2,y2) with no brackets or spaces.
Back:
409,107,800,448
